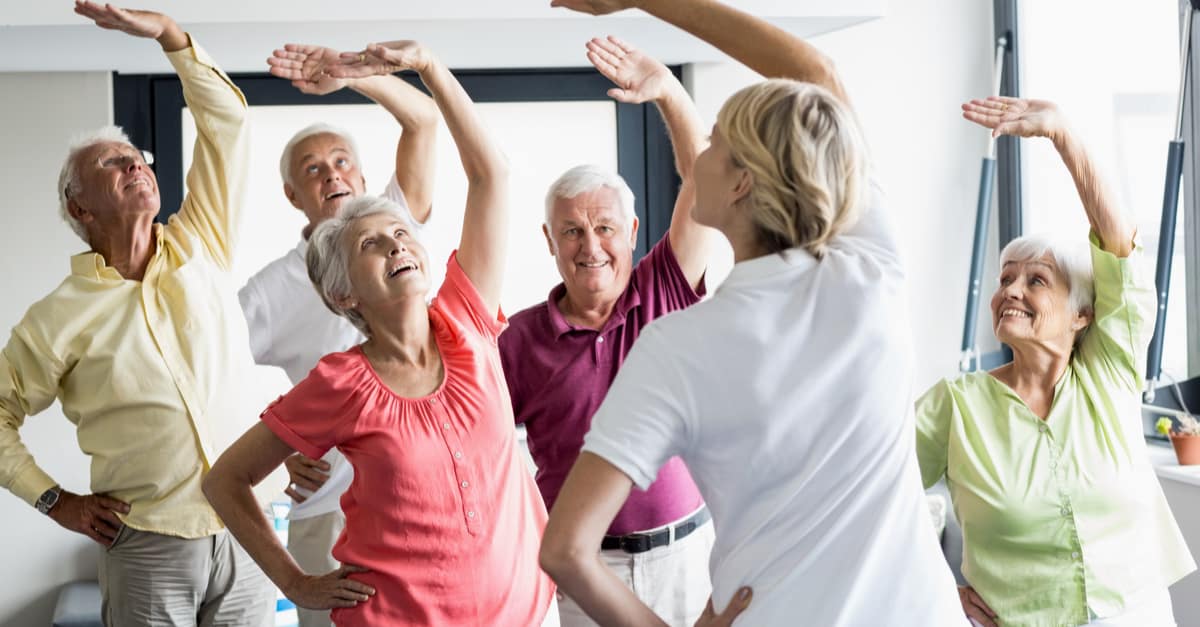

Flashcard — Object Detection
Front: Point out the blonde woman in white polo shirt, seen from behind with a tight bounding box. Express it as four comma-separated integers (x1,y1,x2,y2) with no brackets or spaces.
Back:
541,0,966,627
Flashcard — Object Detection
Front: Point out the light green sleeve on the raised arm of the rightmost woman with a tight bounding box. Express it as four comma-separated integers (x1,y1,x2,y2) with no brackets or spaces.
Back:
1079,232,1158,390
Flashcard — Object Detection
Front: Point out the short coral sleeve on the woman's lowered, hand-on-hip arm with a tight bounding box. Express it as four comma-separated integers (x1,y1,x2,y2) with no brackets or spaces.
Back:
262,357,361,459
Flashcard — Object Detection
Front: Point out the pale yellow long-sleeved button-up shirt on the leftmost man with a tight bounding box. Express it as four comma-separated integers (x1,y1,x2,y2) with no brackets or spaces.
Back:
0,43,257,538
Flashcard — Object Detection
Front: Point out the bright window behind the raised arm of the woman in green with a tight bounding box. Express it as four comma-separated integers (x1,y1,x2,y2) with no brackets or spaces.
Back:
1021,2,1198,381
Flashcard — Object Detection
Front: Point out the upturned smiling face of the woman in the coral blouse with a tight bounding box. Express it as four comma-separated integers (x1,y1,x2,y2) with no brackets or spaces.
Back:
341,213,430,314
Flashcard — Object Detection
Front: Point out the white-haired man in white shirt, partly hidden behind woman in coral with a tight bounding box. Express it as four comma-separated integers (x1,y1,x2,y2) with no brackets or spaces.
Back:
238,44,449,627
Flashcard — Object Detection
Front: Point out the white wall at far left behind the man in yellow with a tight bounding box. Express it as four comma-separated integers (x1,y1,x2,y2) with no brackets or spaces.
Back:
0,73,113,627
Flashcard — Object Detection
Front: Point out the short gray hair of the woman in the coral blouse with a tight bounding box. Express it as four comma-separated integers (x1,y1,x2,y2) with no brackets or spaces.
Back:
305,196,419,338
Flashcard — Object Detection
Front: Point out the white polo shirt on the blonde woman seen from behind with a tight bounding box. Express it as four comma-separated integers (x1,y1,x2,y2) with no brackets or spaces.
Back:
583,177,967,627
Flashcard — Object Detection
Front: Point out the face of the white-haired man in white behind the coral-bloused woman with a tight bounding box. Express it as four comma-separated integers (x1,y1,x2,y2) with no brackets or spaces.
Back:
283,133,366,227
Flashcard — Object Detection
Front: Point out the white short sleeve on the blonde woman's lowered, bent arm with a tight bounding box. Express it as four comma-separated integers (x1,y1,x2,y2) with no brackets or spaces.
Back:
583,324,696,490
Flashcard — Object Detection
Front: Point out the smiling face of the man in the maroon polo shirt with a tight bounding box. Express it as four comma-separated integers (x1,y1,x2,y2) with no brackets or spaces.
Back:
542,186,637,301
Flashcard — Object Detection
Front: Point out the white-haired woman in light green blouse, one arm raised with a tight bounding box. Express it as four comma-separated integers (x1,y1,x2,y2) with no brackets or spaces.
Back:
917,97,1195,627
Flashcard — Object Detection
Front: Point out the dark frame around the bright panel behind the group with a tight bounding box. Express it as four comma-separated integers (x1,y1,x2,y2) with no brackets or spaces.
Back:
113,66,682,258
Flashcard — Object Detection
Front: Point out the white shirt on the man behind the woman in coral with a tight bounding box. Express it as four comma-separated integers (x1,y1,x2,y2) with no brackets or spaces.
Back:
238,177,450,520
